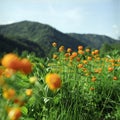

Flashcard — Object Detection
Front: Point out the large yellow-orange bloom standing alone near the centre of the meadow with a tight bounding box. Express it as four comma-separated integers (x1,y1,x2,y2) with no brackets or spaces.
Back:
45,73,61,90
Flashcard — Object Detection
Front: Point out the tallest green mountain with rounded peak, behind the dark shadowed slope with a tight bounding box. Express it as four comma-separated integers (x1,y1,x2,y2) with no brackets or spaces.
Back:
0,21,86,53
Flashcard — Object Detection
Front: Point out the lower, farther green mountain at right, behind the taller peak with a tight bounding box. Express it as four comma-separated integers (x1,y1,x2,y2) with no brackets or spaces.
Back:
68,33,120,49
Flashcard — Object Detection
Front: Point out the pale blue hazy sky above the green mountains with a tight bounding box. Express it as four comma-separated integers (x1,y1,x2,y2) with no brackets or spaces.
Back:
0,0,120,39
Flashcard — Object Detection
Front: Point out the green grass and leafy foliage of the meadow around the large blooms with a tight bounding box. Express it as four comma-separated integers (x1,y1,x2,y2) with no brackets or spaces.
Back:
0,48,120,120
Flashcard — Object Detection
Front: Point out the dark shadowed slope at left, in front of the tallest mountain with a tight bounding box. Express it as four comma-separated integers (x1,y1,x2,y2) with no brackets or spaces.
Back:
0,35,45,57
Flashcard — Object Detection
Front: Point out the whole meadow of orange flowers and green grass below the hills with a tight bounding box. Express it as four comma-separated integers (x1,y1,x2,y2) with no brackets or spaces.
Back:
0,42,120,120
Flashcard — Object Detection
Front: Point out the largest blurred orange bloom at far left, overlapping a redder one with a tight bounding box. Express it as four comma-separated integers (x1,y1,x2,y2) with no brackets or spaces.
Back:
1,53,20,70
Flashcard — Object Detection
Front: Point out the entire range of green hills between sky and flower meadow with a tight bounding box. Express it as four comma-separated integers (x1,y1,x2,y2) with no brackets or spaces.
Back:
0,21,118,55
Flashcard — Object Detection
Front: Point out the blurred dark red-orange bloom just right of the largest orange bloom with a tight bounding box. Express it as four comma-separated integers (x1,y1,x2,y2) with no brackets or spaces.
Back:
20,58,32,74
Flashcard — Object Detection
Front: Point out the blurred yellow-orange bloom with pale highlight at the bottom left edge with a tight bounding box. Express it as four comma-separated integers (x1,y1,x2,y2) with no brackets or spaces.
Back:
8,107,22,120
